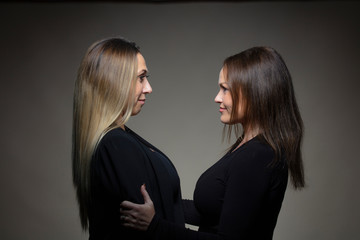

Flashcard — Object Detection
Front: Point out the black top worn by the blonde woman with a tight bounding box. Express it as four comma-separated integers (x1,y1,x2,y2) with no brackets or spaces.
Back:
89,128,184,240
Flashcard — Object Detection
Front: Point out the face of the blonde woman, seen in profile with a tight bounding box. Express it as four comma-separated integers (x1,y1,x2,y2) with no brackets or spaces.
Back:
131,53,152,116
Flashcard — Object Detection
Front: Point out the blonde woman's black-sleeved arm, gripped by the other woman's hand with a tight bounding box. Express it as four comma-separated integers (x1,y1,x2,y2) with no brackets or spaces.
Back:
90,129,156,239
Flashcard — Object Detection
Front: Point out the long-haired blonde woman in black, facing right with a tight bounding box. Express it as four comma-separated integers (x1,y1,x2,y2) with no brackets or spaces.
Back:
72,38,184,240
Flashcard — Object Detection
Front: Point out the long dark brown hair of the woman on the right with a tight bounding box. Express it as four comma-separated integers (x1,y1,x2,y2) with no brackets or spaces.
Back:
223,47,305,189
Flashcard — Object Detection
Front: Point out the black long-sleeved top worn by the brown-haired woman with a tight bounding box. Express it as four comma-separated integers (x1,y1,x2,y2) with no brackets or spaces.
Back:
147,137,288,240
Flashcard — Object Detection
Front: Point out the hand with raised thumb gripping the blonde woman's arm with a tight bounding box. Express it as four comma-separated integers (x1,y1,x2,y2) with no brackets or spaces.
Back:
120,184,155,231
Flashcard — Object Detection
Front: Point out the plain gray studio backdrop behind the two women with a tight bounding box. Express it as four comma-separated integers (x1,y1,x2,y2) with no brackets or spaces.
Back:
0,1,360,240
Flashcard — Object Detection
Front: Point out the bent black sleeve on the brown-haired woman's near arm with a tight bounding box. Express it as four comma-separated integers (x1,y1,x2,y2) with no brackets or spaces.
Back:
148,146,271,240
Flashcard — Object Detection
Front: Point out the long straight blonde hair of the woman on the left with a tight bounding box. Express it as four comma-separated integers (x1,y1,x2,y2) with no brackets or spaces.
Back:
72,38,139,230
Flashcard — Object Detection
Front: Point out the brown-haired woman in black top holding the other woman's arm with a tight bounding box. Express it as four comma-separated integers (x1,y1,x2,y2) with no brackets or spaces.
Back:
120,47,305,240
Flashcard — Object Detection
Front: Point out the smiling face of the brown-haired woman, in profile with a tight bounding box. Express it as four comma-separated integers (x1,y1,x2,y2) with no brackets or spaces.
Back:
215,68,244,124
